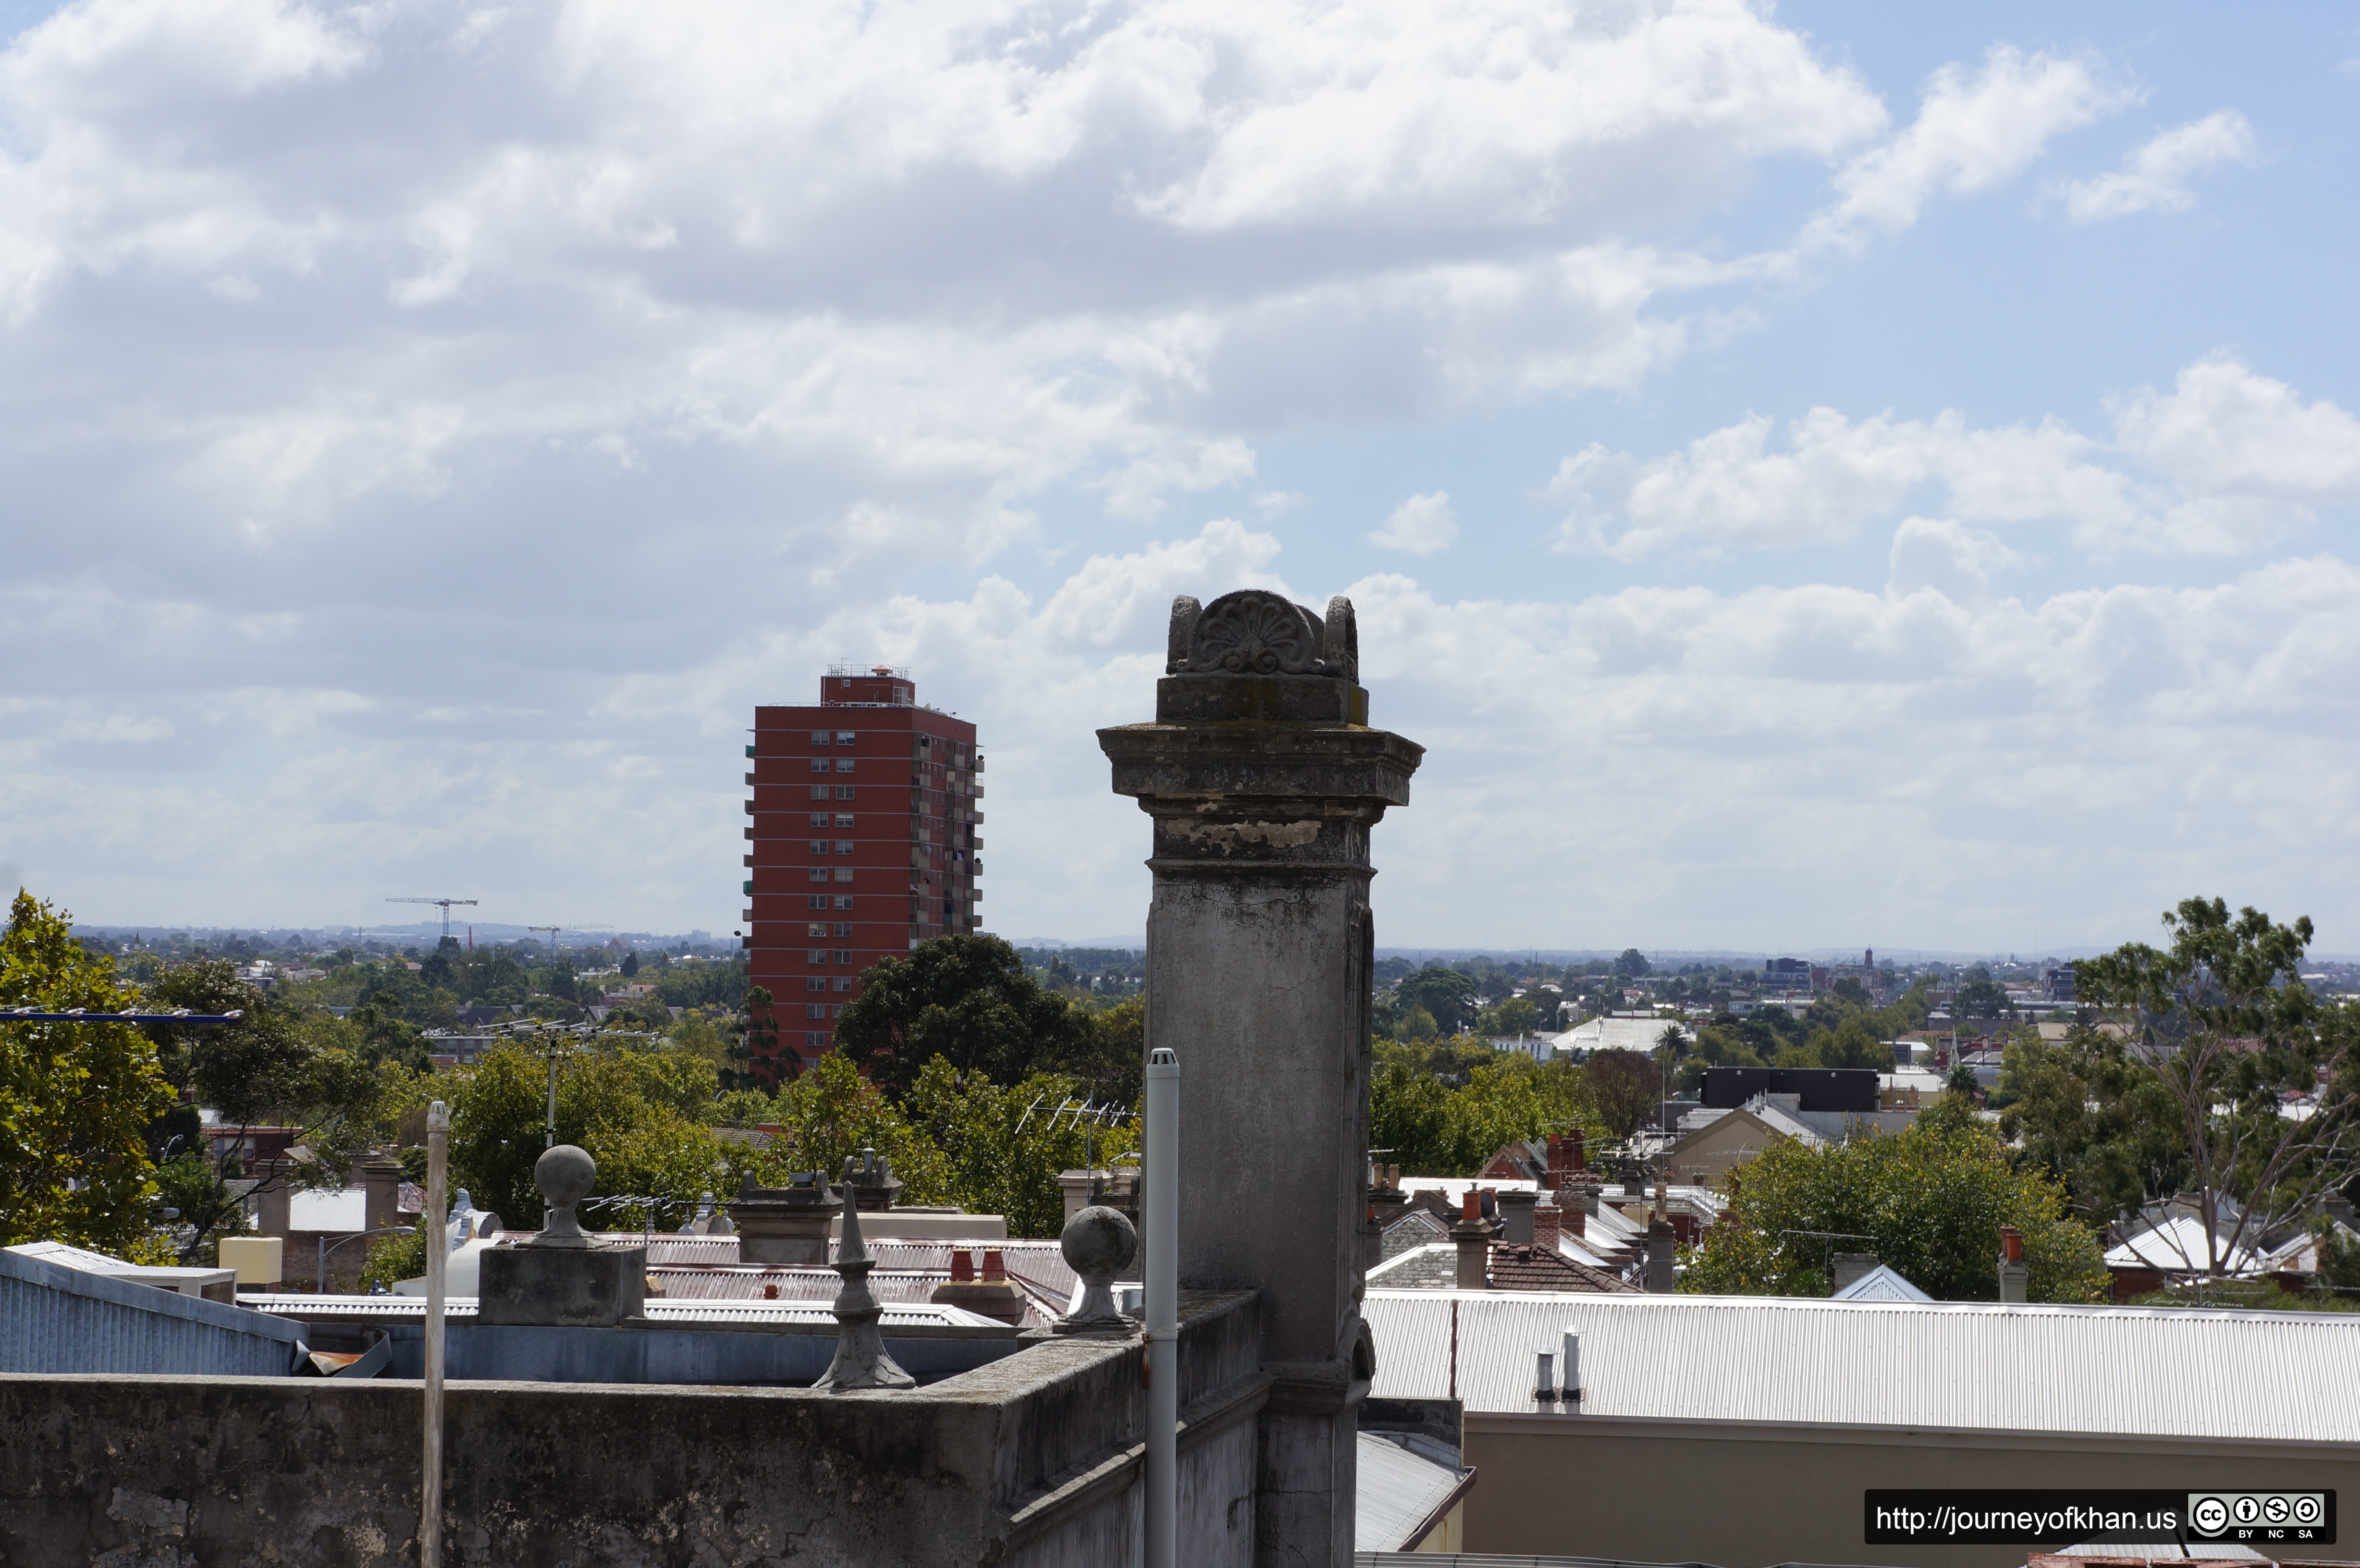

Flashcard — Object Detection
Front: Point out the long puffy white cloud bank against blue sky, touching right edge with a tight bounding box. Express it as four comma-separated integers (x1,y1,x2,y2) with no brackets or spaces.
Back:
1548,356,2360,560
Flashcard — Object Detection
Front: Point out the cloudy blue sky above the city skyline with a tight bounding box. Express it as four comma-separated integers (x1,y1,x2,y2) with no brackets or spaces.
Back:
0,0,2360,952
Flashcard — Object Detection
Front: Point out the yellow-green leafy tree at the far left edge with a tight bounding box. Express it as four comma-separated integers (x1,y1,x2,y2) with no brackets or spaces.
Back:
0,890,172,1251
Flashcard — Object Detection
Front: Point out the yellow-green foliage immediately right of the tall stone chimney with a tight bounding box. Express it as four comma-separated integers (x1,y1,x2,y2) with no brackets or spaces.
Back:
1369,1049,1598,1176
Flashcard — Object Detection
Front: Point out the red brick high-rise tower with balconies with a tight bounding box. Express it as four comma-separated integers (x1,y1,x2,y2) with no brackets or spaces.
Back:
746,666,984,1075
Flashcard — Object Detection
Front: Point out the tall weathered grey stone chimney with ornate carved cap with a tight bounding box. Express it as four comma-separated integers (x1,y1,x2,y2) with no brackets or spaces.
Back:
1097,590,1423,1568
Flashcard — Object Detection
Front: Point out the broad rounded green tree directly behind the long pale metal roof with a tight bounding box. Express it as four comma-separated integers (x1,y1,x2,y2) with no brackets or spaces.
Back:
1680,1096,2107,1301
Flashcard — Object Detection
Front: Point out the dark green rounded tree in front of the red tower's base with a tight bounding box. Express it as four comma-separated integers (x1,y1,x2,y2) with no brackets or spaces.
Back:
836,935,1093,1093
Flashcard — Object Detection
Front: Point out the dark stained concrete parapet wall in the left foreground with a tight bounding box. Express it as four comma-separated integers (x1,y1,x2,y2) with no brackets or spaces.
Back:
0,1297,1265,1568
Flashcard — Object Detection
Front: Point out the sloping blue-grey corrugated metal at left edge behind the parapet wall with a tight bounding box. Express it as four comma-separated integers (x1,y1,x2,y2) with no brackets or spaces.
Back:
0,1249,302,1377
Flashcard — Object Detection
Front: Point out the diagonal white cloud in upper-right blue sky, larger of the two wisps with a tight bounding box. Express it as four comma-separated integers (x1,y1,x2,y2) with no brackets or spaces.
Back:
1806,45,2131,248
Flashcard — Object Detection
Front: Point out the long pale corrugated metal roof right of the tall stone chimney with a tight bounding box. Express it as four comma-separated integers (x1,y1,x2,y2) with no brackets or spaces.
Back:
1362,1289,2360,1443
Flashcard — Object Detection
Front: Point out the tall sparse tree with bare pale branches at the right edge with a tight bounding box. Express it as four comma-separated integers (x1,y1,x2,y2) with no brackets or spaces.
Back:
2075,897,2360,1275
